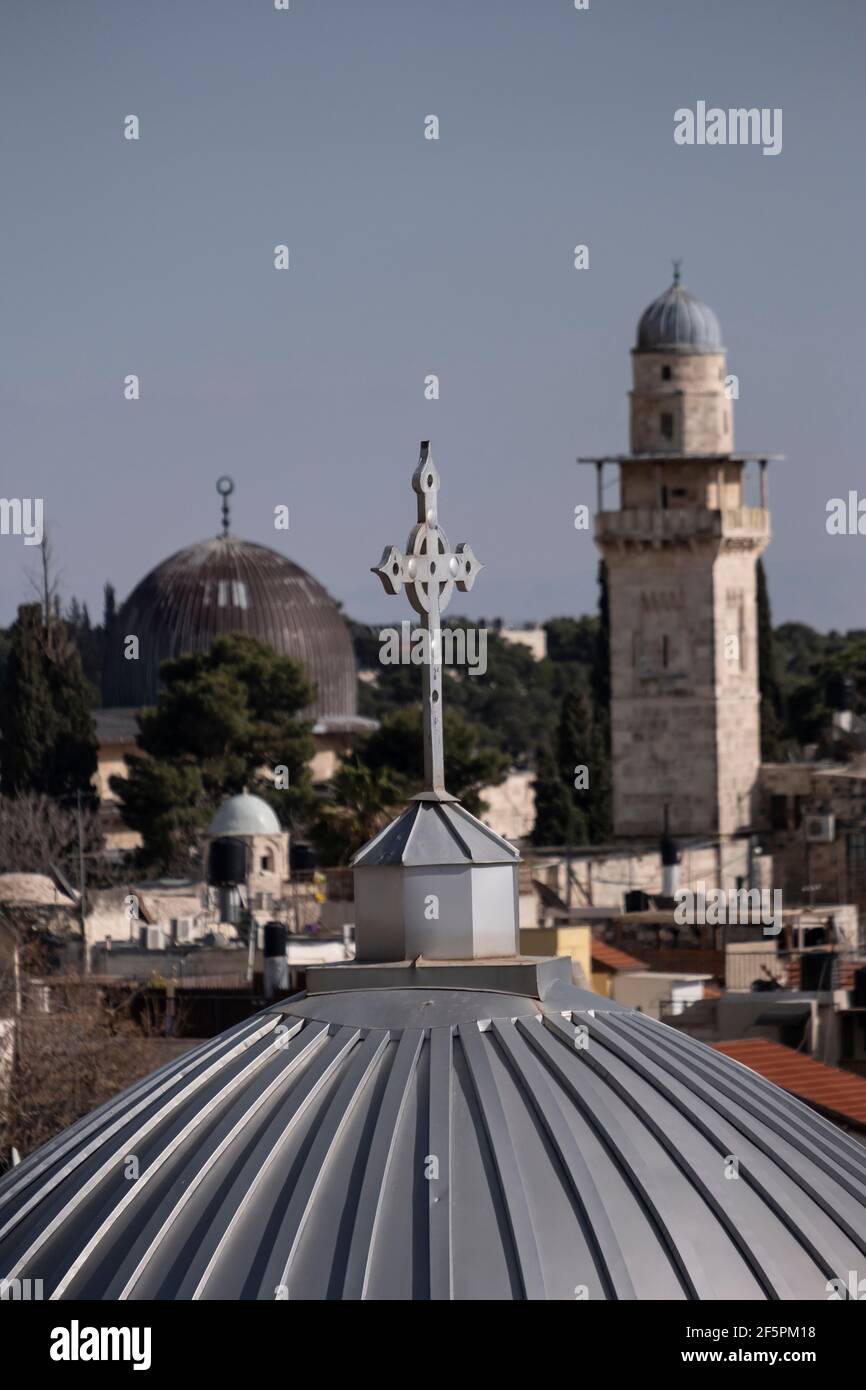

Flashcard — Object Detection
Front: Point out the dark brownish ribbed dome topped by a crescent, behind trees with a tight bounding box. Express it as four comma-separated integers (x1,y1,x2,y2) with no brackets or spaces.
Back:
103,535,356,719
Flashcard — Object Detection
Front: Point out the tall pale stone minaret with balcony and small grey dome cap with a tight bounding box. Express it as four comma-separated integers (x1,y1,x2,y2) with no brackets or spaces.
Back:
580,270,770,837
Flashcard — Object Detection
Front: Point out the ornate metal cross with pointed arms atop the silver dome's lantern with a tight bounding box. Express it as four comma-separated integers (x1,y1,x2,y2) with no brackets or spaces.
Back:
371,439,484,801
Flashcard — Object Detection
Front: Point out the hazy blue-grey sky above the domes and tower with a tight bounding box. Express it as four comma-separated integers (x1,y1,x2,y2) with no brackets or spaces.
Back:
0,0,866,630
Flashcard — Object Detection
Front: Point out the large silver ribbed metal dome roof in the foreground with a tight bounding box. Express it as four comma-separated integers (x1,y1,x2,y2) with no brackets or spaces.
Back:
0,972,866,1300
